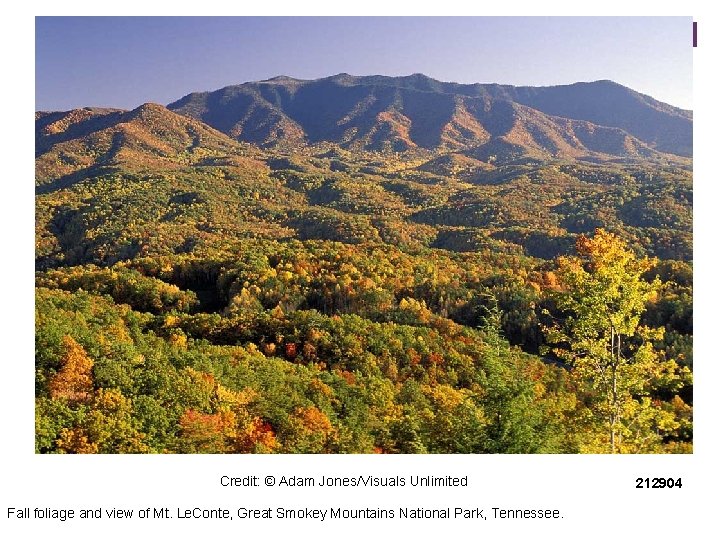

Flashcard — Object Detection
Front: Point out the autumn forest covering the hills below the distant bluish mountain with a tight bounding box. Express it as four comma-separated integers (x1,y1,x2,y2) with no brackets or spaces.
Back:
35,77,693,453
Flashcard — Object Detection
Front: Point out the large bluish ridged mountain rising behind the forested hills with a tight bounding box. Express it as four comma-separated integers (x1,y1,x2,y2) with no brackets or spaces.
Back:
168,74,692,159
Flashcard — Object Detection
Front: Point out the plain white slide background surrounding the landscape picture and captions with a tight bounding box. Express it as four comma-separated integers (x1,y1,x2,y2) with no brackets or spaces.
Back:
0,1,720,539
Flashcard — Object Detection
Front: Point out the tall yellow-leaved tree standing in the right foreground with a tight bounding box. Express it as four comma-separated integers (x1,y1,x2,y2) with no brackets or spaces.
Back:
546,229,680,453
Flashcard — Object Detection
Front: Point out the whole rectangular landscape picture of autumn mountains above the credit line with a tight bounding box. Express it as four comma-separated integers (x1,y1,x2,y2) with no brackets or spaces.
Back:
32,16,694,454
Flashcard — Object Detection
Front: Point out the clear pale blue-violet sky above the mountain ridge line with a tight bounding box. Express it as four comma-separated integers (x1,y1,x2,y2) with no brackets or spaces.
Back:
35,17,692,110
